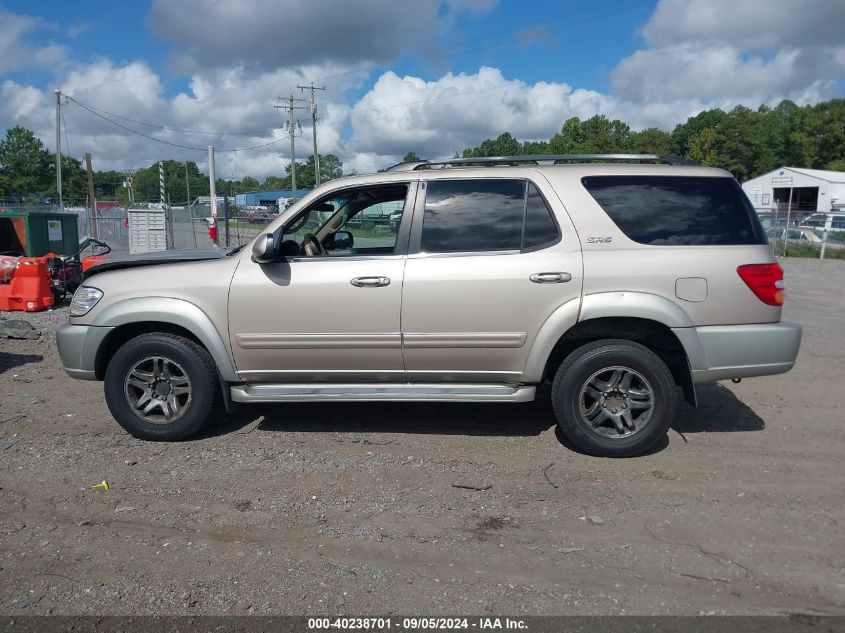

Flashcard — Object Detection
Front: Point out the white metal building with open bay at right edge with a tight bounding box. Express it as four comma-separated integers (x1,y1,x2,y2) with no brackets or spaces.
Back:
742,167,845,216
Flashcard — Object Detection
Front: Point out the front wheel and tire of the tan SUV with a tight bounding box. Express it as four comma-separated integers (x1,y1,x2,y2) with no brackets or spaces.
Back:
104,332,221,442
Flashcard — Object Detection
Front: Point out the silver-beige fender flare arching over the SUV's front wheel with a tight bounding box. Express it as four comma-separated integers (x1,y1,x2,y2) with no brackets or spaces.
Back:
91,297,239,382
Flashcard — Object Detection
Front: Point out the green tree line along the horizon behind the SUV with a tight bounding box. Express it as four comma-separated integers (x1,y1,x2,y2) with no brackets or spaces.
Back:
0,99,845,203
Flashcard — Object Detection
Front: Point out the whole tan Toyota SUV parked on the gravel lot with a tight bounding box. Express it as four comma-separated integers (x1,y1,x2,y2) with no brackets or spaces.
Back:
58,155,801,456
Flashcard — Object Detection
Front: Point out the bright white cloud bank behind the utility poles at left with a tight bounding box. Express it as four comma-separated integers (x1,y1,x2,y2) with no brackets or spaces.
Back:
0,54,360,177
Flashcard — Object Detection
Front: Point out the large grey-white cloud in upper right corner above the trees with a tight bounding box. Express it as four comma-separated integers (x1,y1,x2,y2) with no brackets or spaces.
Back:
612,0,845,107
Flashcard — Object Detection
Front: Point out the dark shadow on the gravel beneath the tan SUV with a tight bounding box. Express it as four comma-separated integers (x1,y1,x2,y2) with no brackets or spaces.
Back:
203,385,765,444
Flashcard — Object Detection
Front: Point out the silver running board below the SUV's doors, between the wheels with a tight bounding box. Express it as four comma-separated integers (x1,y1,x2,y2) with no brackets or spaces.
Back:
232,383,536,402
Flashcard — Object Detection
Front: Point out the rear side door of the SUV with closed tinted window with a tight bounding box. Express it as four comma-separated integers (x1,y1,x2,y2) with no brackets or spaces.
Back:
401,170,581,383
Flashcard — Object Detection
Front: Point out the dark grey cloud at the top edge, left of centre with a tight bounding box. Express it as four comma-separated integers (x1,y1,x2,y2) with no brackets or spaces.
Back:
148,0,494,70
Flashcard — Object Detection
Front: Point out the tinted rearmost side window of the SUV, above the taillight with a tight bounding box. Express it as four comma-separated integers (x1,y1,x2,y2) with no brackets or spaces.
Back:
581,176,766,246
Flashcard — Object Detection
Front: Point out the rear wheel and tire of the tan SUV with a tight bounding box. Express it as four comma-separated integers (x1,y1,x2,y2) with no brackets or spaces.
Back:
552,339,675,457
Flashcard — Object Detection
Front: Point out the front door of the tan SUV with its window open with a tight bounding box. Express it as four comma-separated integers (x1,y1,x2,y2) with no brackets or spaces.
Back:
229,181,417,383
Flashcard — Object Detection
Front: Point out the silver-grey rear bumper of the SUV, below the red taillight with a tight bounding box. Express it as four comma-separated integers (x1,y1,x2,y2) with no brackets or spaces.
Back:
672,321,801,383
